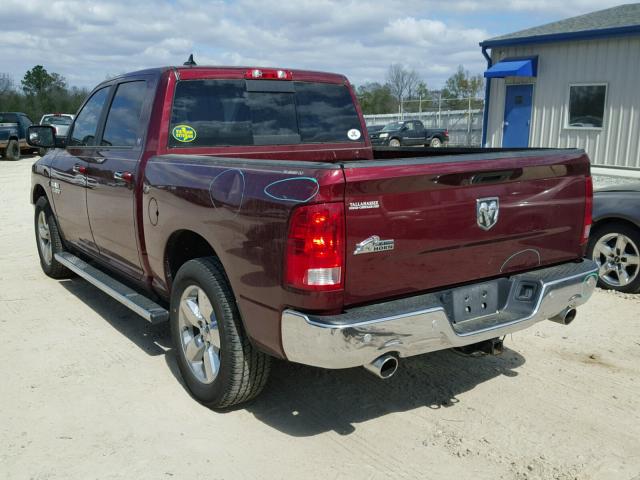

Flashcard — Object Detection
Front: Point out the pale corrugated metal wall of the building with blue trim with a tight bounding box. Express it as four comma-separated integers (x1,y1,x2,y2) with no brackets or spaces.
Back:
487,37,640,169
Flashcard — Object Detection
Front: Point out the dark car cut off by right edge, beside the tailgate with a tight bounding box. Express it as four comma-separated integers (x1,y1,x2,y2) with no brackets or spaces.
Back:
587,183,640,293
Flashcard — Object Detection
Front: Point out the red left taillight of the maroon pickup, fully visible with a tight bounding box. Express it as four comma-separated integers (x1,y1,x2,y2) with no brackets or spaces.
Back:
285,203,345,290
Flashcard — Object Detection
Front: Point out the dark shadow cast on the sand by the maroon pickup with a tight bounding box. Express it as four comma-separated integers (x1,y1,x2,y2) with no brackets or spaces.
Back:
61,279,525,437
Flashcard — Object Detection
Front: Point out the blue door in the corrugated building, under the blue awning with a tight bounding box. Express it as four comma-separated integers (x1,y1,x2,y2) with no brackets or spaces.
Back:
502,85,533,147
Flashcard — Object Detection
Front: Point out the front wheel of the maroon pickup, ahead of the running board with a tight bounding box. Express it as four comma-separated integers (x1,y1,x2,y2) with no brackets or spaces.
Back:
34,197,73,278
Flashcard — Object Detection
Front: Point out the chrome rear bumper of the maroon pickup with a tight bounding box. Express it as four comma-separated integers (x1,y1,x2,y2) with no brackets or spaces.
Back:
282,260,598,368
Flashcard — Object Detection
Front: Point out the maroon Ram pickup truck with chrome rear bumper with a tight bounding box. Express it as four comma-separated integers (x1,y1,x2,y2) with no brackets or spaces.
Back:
29,66,597,408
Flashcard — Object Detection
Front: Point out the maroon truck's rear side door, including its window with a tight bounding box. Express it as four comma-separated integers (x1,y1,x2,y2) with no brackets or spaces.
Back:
87,80,150,279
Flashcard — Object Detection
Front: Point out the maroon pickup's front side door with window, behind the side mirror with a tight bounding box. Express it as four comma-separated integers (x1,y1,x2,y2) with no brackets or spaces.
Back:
51,86,110,253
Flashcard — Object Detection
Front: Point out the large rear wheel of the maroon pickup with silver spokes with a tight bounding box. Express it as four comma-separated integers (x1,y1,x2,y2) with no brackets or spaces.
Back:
170,257,271,409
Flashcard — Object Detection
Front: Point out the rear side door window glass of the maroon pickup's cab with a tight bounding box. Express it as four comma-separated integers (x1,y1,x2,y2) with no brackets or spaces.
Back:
101,81,146,147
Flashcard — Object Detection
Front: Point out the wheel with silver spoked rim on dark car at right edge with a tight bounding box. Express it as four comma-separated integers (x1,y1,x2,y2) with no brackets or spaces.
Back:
587,223,640,293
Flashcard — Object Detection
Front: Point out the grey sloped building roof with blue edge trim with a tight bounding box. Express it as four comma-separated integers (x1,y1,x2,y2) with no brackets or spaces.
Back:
480,3,640,47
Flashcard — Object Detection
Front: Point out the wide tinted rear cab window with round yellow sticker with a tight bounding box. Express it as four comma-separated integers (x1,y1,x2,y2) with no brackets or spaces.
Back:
169,80,361,147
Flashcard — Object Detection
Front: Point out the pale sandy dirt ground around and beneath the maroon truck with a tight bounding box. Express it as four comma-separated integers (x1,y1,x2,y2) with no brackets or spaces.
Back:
0,157,640,480
